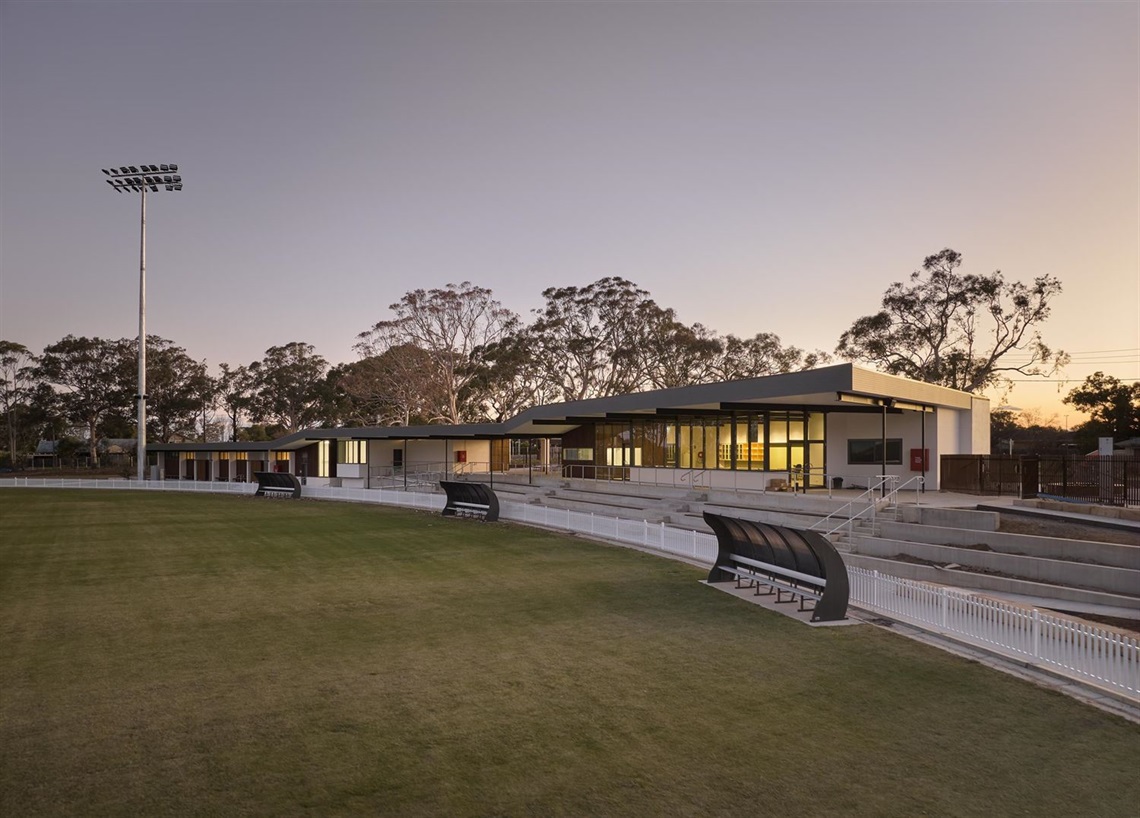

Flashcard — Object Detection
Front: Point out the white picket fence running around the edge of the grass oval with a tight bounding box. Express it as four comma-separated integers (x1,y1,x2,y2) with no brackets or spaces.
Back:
0,477,1140,702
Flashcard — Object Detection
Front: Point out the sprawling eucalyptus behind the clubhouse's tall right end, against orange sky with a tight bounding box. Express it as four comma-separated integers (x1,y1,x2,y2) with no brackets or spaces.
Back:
836,248,1067,392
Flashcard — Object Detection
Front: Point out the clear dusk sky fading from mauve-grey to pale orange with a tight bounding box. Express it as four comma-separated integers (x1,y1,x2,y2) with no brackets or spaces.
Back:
0,0,1140,424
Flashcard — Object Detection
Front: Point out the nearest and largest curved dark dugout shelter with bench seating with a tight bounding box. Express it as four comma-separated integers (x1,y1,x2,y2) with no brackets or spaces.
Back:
705,512,849,622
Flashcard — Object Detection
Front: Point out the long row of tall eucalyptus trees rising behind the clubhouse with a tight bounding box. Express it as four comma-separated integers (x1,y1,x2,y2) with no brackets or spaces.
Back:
0,250,1121,464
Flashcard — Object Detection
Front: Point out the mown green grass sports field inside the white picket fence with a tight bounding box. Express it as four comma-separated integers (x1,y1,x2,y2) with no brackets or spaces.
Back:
0,489,1140,818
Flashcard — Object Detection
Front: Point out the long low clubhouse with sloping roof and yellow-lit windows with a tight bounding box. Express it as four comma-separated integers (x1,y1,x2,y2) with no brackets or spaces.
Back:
147,363,990,490
